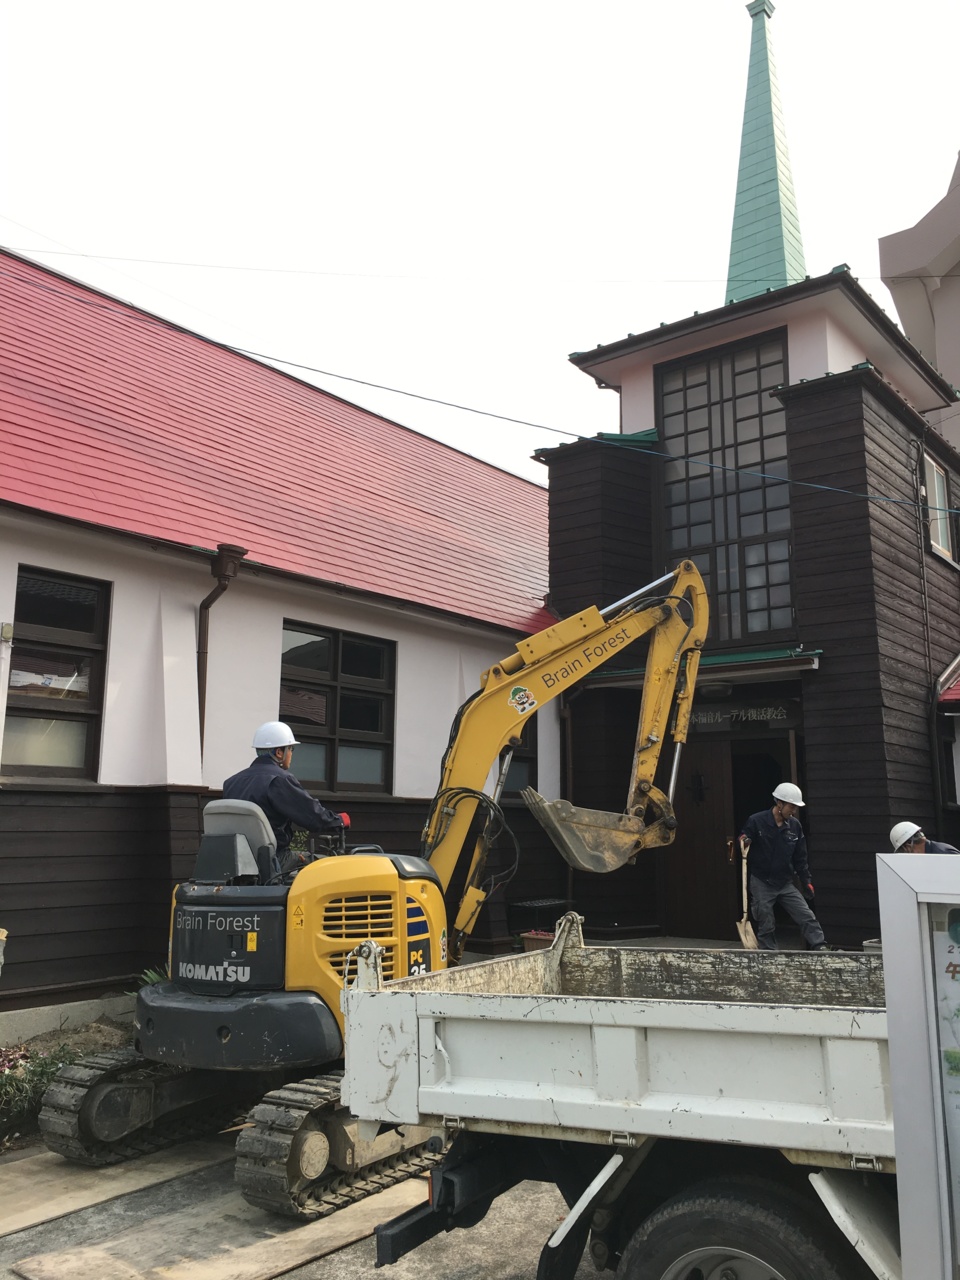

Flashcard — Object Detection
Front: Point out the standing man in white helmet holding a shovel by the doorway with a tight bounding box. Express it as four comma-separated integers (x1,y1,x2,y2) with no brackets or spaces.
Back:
740,782,826,951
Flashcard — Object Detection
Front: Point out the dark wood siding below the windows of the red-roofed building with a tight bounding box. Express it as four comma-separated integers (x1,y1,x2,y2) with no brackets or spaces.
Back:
0,787,568,1010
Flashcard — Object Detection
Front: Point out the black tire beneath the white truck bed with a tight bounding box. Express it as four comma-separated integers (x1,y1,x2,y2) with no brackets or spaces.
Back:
617,1178,867,1280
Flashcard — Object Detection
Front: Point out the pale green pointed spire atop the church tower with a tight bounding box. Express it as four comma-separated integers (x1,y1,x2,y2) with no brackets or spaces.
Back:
726,0,806,302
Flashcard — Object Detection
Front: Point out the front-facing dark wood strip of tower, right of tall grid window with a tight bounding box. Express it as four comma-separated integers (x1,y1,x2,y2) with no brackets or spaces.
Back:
786,373,906,945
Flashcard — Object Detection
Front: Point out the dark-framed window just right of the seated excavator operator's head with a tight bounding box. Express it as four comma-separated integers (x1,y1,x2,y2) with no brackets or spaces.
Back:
279,621,396,792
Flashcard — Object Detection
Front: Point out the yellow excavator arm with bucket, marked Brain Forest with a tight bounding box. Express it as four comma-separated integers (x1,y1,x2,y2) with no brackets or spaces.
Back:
421,561,708,956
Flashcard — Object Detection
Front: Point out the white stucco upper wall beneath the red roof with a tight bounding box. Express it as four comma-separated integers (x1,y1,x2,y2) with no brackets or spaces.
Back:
0,513,559,797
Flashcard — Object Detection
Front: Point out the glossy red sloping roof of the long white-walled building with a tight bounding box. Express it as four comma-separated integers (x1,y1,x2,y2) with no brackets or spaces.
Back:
0,251,553,631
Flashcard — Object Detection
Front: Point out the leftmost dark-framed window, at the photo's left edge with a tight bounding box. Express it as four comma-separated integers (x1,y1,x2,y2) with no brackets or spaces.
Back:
0,566,110,780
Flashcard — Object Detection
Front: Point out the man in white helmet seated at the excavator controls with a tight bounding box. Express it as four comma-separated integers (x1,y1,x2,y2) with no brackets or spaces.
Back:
223,721,349,867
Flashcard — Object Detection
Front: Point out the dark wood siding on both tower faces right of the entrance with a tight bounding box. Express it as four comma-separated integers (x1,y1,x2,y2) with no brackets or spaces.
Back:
785,371,960,945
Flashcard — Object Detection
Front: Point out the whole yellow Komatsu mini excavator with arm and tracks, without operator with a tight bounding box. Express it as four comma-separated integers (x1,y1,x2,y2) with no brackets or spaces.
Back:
40,561,708,1219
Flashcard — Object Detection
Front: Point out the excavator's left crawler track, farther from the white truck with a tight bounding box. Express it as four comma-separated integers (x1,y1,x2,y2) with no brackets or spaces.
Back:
38,1048,249,1169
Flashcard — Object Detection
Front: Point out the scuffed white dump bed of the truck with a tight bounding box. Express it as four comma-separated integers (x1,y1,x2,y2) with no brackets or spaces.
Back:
343,915,893,1170
